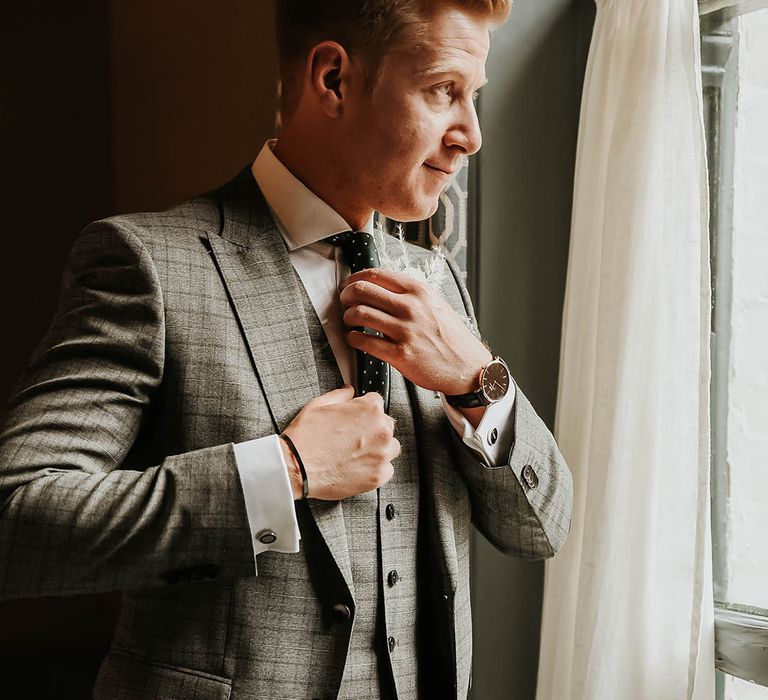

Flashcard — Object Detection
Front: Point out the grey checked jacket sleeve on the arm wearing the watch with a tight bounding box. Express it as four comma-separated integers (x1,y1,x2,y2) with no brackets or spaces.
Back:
445,254,573,559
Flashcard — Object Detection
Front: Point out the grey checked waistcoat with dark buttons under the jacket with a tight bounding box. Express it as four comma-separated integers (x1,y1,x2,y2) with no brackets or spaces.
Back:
300,274,419,700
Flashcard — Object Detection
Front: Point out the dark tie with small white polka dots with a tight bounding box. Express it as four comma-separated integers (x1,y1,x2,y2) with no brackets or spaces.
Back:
325,231,389,407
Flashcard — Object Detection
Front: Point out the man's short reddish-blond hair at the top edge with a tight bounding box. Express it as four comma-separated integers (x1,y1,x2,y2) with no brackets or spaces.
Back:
275,0,512,116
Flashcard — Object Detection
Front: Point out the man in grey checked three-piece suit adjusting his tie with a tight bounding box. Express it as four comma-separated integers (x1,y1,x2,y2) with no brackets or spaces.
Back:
0,0,571,699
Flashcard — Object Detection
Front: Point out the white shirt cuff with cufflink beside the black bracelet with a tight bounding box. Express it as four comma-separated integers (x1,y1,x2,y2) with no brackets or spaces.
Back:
234,435,301,569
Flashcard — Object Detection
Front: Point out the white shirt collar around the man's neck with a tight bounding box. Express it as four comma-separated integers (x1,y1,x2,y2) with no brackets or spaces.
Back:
251,139,373,250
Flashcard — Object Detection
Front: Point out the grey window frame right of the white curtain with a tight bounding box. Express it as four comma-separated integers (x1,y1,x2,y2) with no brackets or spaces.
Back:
701,7,768,700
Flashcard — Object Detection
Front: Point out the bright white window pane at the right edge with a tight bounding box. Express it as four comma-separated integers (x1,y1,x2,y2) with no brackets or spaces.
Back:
717,4,768,608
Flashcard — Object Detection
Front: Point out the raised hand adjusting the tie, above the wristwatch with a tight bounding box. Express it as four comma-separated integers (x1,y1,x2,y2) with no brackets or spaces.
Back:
340,268,493,395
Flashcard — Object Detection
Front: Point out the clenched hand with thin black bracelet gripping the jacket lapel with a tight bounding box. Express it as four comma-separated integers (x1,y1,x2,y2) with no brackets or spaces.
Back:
281,386,400,501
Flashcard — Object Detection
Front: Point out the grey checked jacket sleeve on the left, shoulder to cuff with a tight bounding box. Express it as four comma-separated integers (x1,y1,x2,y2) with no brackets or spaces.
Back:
0,222,255,599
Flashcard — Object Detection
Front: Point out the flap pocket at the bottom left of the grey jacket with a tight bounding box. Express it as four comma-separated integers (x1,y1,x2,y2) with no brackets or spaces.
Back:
93,650,232,700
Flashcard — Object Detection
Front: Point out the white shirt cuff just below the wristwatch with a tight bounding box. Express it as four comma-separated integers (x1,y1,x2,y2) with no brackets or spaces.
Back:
440,382,516,467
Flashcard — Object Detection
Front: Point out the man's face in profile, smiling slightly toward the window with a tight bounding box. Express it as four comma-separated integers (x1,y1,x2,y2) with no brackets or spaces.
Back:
337,5,489,221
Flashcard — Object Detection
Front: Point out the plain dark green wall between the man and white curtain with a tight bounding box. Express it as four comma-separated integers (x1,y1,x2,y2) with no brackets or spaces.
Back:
473,0,594,700
